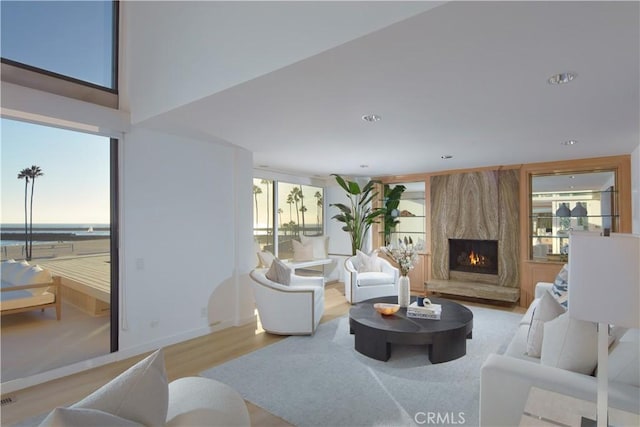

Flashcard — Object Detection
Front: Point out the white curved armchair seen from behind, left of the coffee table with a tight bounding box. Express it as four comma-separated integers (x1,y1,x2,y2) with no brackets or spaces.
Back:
250,269,324,335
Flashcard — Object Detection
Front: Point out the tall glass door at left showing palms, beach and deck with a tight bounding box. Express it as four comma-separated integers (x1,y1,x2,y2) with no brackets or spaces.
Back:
0,119,117,381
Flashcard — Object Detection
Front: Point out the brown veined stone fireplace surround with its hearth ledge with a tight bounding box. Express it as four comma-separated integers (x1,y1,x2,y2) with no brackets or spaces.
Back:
427,169,520,302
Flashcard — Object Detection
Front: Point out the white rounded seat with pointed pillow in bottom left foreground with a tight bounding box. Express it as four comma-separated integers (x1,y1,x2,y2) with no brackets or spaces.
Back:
40,350,251,427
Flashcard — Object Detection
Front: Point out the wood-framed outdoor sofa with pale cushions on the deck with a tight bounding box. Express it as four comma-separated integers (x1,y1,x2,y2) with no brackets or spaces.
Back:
0,259,62,320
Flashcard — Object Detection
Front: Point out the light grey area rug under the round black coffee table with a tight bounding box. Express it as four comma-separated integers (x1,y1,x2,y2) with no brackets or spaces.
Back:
200,307,522,427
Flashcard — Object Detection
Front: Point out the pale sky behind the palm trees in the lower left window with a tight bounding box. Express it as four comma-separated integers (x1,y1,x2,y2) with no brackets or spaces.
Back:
0,119,110,225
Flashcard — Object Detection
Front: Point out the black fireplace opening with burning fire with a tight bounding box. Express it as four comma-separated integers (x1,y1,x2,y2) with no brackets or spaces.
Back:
449,239,498,274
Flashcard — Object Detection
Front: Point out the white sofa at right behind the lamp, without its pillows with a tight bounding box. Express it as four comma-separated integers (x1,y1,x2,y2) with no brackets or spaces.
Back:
480,282,640,426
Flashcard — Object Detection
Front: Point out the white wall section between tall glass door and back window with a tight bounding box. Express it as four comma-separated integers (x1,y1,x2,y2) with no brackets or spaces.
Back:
120,127,253,349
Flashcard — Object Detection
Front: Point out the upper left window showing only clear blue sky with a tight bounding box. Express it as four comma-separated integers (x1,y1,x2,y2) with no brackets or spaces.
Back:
1,1,117,90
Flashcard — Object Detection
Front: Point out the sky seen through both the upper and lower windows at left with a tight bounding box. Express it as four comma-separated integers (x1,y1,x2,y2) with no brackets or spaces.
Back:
0,0,112,225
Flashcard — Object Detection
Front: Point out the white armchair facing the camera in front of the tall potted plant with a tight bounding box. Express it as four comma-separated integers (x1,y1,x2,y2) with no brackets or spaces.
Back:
344,256,400,304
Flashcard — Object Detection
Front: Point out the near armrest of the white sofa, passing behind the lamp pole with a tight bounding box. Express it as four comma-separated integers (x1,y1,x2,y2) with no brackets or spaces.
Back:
480,354,640,426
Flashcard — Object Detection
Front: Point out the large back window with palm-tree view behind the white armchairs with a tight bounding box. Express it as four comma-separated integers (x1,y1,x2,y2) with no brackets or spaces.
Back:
253,178,324,259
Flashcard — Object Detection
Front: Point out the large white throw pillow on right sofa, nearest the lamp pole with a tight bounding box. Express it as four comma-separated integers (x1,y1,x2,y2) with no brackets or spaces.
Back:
540,313,598,375
